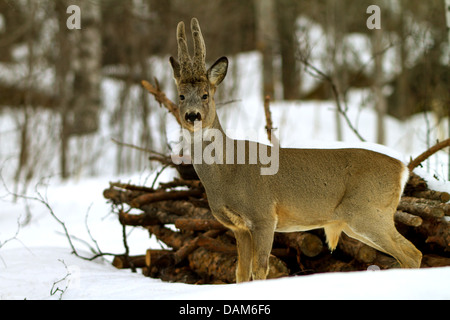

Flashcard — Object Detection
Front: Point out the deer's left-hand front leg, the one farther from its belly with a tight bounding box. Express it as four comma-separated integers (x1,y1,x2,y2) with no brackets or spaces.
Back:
234,229,253,283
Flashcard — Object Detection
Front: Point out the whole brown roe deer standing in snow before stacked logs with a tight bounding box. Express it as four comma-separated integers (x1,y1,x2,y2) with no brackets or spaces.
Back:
170,18,422,282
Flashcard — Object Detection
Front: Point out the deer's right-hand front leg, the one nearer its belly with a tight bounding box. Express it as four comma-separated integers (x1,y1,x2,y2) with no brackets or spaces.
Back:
251,221,275,280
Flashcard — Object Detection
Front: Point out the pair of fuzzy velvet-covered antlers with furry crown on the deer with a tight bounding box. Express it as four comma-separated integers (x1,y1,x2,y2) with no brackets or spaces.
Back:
171,18,206,82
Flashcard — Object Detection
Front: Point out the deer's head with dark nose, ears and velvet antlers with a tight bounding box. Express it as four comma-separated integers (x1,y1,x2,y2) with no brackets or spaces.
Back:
170,18,228,132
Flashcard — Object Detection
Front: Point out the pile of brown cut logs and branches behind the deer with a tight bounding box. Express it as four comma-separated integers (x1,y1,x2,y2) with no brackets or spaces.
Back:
103,81,450,284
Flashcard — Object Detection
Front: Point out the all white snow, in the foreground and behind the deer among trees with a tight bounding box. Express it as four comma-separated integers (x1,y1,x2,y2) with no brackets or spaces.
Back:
0,54,450,300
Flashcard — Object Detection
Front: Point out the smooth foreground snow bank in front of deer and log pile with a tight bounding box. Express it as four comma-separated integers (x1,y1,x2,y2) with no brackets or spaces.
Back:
0,247,450,300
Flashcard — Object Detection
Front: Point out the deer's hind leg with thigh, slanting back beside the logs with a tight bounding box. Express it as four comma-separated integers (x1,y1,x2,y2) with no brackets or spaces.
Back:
344,208,422,268
